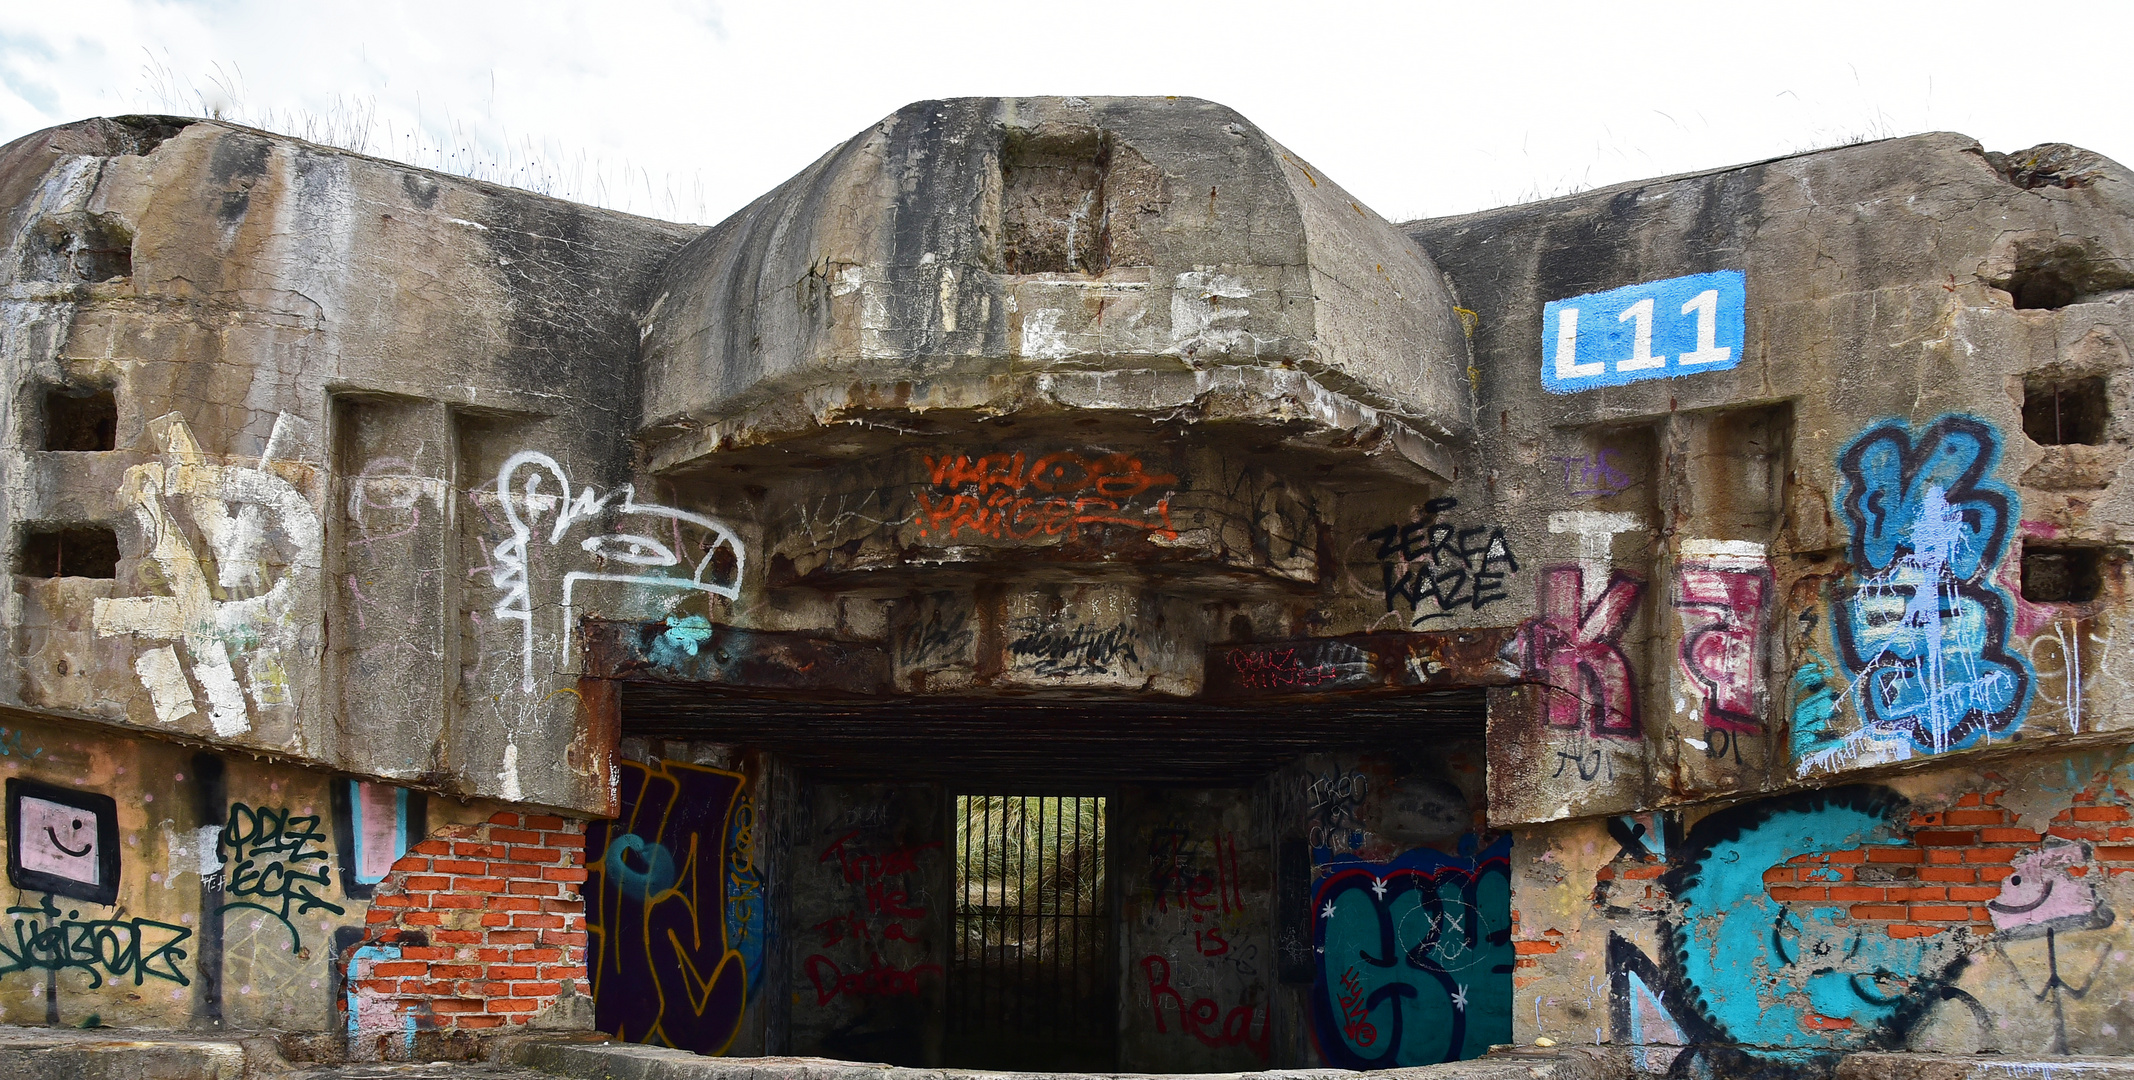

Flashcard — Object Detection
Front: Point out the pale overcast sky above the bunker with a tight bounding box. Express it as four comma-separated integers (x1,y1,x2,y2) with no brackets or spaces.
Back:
0,0,2134,222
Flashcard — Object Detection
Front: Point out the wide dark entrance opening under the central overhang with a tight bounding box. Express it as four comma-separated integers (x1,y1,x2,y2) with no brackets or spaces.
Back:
610,679,1511,1074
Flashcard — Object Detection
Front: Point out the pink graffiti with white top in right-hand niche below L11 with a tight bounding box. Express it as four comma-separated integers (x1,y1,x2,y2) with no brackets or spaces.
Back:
1673,540,1771,734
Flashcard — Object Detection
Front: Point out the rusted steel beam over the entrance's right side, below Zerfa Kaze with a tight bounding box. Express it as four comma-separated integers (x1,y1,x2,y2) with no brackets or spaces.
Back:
1204,628,1519,700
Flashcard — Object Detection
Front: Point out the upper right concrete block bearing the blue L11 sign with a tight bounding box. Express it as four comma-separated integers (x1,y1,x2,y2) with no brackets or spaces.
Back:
1413,134,2134,822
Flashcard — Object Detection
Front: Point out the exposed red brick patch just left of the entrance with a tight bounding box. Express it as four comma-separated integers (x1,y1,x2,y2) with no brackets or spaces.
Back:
344,811,585,1042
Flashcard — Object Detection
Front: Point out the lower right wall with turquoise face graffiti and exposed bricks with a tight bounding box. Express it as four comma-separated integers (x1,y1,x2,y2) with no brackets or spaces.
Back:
1513,749,2134,1076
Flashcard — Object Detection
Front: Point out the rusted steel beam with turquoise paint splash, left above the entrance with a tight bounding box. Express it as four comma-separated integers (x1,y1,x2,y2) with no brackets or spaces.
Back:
580,619,890,694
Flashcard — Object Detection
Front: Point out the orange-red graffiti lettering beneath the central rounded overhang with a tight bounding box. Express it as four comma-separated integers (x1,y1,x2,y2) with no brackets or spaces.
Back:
918,450,1178,540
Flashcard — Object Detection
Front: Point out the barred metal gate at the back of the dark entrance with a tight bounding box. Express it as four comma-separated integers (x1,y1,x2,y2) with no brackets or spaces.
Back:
945,794,1118,1071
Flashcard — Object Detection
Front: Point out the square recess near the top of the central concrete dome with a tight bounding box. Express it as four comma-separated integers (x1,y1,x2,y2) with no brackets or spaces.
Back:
1001,132,1112,273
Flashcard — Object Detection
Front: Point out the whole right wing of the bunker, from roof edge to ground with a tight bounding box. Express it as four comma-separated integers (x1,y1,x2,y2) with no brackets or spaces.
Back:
1413,134,2134,1074
